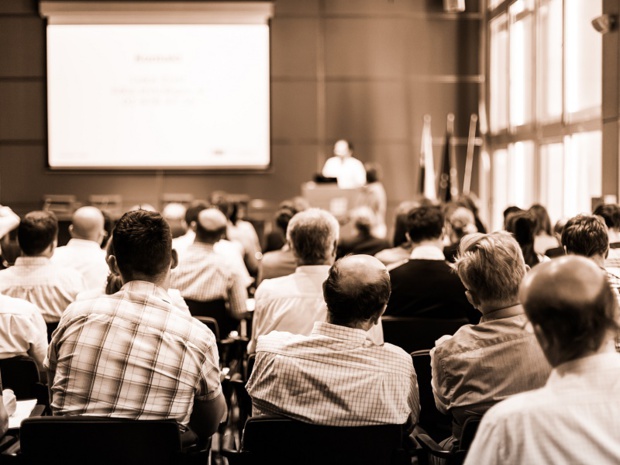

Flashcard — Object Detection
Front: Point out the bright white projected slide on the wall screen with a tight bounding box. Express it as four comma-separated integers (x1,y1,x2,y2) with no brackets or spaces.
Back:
47,24,270,170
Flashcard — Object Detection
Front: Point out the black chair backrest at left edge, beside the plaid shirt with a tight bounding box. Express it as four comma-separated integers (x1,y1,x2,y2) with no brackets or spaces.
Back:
0,356,49,406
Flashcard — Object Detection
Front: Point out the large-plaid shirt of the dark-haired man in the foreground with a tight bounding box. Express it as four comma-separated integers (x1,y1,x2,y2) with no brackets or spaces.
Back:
46,281,221,426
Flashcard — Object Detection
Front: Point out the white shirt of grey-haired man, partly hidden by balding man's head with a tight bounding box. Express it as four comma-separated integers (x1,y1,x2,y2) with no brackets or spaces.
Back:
248,265,383,353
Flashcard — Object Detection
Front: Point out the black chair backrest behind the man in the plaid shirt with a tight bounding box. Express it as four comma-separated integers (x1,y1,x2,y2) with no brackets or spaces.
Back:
20,416,181,465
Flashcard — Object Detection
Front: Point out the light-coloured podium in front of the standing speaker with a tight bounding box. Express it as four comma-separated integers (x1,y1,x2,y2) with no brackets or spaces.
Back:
301,182,362,220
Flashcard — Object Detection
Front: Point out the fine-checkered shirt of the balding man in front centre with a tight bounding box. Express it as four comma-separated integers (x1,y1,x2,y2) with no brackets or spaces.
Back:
247,322,420,426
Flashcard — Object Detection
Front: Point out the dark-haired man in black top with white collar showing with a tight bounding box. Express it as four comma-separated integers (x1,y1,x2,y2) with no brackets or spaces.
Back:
385,206,480,323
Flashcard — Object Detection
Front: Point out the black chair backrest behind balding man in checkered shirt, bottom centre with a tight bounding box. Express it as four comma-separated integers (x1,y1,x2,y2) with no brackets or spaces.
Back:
223,416,411,465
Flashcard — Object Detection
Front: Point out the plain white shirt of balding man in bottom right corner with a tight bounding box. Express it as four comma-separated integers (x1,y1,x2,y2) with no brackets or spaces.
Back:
465,352,620,465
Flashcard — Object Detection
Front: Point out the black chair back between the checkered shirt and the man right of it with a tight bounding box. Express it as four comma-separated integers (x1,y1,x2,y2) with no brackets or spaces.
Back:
411,350,452,441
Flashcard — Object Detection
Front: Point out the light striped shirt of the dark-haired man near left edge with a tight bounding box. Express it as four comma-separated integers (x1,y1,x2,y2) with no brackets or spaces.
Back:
0,257,85,323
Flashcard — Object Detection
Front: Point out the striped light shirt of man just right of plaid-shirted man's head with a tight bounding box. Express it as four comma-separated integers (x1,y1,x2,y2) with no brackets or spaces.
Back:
170,242,248,318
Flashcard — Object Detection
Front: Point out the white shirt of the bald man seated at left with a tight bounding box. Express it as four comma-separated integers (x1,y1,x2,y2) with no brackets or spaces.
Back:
52,238,109,289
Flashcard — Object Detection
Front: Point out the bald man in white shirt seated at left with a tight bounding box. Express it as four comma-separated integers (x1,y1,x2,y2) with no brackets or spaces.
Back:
52,207,108,289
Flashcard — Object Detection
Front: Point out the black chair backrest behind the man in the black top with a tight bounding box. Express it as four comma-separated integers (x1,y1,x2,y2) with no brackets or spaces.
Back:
381,316,469,353
